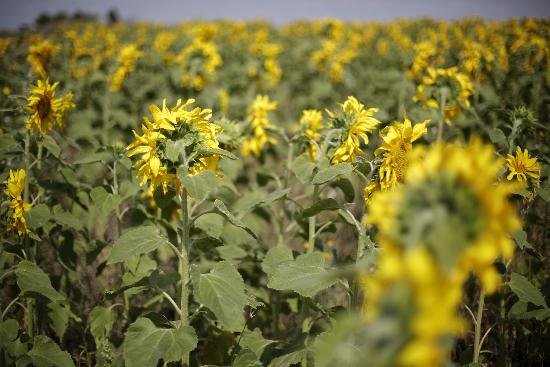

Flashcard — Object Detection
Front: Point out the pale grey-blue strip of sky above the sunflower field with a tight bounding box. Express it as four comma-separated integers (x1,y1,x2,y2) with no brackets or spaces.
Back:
0,0,550,29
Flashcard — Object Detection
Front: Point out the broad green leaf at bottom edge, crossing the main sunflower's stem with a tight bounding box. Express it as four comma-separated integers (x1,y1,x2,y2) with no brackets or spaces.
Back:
122,318,198,367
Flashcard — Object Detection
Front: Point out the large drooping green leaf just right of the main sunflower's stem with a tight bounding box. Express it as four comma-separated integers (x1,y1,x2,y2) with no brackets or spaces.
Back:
195,261,247,331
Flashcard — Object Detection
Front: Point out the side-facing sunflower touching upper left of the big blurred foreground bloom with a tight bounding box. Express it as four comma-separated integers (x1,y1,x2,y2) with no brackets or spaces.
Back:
374,114,430,191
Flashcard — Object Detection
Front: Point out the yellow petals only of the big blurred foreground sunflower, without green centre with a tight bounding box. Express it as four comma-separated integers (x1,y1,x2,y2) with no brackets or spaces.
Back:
362,139,520,366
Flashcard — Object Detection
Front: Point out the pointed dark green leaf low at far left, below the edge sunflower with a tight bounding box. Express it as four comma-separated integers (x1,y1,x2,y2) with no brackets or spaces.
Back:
15,260,65,301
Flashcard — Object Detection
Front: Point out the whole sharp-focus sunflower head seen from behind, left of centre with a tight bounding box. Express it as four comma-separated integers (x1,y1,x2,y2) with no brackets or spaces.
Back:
127,99,221,193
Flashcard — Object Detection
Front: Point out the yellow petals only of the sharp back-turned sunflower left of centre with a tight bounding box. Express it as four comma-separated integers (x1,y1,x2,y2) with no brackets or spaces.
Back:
127,99,221,193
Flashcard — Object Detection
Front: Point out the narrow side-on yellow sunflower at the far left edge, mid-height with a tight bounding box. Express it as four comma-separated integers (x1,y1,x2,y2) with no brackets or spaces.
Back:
4,169,31,236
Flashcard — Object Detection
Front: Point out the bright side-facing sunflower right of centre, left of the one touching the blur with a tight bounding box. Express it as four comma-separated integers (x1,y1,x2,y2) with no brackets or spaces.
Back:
327,96,380,164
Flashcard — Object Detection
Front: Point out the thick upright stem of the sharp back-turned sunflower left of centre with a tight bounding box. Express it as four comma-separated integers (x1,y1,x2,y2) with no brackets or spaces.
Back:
179,188,190,366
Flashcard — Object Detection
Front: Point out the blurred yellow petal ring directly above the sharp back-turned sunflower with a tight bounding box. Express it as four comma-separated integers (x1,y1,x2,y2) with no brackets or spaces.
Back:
180,37,222,90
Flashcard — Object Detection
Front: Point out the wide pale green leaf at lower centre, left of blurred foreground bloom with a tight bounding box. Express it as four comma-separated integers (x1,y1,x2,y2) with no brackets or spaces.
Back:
267,252,336,297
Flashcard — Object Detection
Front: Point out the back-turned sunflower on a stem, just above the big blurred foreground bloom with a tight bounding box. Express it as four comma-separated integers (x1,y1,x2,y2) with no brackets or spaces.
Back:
413,67,474,124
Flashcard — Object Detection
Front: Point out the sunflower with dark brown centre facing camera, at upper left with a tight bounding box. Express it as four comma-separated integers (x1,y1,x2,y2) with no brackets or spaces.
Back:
25,80,75,134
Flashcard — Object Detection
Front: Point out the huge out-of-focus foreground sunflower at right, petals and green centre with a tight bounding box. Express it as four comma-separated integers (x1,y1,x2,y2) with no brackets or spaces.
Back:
366,139,519,366
